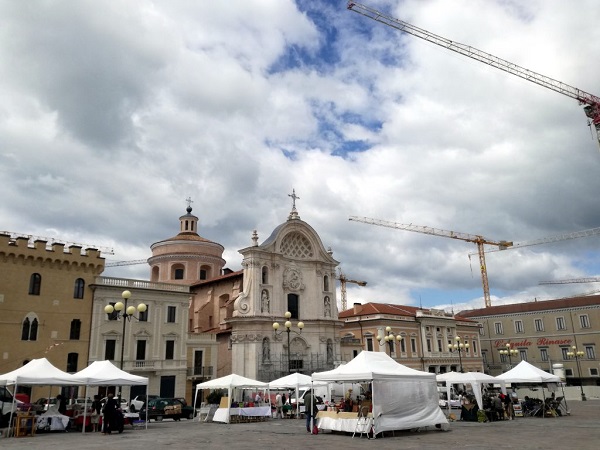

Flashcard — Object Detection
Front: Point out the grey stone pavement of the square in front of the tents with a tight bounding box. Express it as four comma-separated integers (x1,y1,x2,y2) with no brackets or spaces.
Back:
0,400,600,450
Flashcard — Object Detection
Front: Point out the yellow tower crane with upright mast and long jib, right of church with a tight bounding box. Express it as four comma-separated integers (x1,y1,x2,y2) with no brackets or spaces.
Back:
350,216,512,308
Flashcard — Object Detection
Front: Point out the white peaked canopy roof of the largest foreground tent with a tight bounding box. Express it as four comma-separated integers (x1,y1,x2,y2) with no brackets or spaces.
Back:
312,350,435,381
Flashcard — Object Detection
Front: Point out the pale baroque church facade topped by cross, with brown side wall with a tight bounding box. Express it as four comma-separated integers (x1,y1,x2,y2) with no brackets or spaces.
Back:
190,193,342,381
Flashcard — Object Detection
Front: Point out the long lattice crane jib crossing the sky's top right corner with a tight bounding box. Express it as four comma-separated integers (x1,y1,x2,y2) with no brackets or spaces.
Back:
347,1,600,146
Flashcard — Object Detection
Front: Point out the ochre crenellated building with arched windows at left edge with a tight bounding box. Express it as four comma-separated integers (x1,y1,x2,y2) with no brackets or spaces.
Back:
0,234,104,401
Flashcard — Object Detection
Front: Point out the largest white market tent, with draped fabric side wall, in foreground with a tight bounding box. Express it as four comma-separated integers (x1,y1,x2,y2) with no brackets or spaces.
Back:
312,351,448,434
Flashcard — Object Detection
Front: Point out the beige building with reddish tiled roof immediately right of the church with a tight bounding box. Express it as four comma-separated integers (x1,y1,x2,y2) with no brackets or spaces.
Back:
339,303,483,373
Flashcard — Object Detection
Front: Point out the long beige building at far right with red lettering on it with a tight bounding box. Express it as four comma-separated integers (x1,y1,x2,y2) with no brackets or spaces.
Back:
460,296,600,385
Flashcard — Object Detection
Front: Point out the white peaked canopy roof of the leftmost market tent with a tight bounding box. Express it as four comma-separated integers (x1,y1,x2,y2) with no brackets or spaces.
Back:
0,358,82,386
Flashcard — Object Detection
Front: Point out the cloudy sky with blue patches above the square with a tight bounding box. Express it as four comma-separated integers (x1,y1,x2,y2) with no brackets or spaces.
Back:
0,0,600,310
